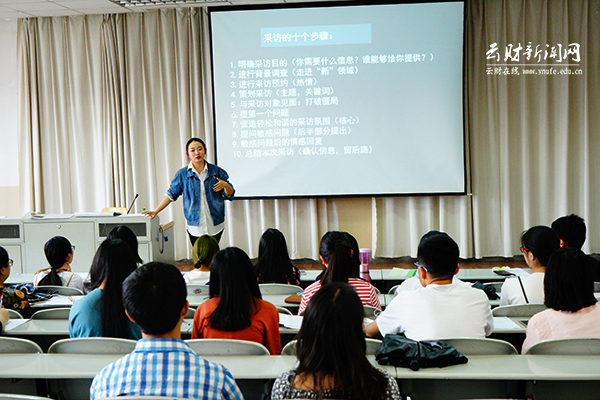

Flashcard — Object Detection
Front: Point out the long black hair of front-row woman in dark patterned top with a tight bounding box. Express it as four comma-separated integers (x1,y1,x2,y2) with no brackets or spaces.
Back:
295,282,387,399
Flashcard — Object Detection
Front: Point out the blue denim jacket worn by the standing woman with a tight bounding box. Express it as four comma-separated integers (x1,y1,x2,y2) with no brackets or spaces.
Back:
167,162,235,226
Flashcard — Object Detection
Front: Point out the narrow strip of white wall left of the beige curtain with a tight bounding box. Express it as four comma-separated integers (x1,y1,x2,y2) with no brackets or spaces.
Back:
0,20,21,216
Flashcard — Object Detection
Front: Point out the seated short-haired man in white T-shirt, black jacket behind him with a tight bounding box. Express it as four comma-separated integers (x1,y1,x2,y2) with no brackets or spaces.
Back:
366,231,494,340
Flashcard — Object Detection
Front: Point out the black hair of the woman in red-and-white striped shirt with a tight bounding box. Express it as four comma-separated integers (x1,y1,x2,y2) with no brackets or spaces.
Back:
319,231,359,285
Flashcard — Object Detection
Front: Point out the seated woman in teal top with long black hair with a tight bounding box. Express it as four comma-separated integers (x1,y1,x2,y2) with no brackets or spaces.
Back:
69,239,142,340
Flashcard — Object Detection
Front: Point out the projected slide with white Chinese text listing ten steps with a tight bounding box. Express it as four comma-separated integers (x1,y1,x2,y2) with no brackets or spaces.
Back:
210,2,465,198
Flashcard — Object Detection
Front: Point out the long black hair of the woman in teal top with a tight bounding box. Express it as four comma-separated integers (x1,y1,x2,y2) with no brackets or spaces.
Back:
88,239,137,339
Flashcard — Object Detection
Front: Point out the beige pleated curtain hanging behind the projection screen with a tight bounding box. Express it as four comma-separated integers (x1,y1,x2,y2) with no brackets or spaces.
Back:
18,0,600,259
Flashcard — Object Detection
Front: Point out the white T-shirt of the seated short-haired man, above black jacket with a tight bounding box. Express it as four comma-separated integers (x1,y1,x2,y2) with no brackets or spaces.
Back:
377,283,494,340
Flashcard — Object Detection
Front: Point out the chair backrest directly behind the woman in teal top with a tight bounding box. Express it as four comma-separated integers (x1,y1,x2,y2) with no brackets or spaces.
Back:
48,337,137,354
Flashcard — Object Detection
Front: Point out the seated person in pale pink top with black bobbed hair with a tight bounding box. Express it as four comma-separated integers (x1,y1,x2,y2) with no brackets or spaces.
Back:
522,247,600,354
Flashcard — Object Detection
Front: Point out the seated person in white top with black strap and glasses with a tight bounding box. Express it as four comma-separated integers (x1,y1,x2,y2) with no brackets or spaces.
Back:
500,226,560,306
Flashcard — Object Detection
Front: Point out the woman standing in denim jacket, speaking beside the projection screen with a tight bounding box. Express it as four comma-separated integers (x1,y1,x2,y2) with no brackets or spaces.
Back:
142,138,235,246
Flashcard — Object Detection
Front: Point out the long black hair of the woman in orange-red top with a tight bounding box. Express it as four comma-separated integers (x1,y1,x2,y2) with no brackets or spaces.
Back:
208,247,262,332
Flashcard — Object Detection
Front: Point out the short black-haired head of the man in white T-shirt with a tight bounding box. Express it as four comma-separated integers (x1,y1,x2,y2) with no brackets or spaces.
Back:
417,231,460,276
